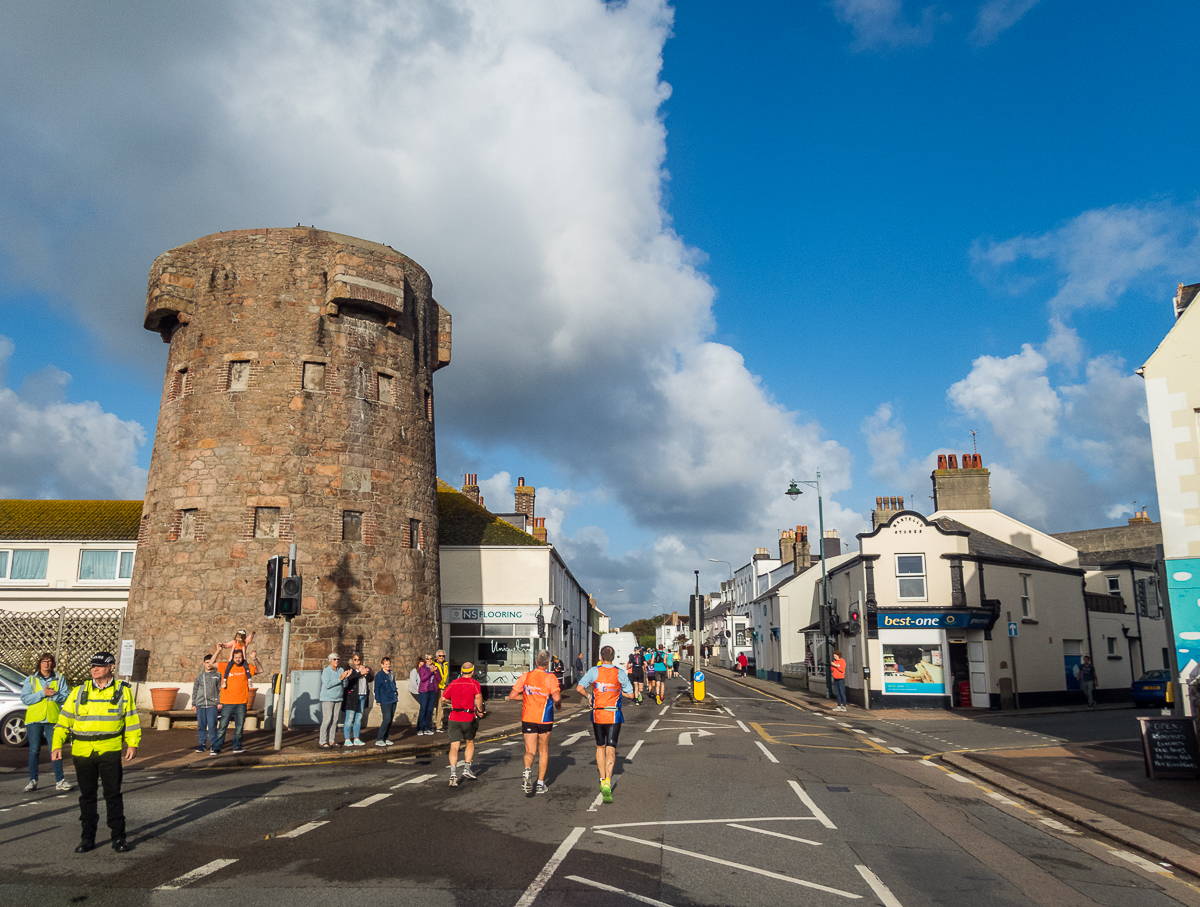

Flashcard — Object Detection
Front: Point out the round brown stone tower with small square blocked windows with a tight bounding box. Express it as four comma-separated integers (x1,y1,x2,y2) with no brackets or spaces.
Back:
124,227,450,681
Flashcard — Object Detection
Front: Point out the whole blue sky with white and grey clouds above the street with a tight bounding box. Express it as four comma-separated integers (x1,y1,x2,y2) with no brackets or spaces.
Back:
0,0,1200,620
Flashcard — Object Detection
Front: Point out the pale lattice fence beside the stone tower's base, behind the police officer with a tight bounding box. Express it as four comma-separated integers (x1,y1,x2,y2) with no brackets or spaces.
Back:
0,607,125,684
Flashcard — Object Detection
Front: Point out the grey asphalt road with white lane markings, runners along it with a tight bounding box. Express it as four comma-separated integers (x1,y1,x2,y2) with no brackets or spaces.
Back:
0,680,1200,907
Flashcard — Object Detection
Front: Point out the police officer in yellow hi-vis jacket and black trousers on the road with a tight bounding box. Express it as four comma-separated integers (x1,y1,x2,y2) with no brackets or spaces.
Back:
50,651,142,853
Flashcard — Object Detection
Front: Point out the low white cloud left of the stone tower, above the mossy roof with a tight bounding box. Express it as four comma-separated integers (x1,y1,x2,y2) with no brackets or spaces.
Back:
0,336,146,500
